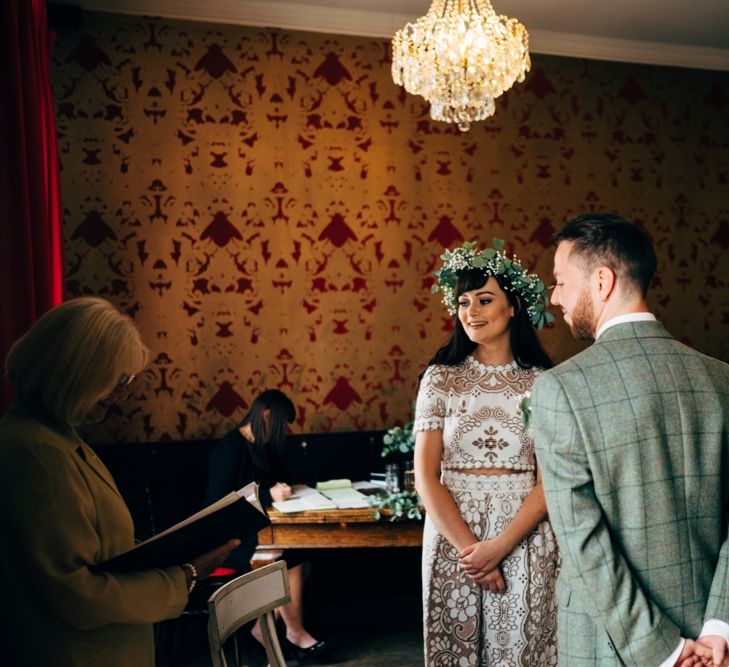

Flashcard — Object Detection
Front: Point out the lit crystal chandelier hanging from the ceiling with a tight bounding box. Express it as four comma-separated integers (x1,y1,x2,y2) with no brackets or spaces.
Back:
392,0,531,132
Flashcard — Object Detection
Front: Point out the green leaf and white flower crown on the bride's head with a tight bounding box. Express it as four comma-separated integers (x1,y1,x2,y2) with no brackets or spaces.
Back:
431,239,554,329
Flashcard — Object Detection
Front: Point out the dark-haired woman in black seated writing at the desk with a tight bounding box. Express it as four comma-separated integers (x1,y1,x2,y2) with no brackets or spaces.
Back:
206,389,327,660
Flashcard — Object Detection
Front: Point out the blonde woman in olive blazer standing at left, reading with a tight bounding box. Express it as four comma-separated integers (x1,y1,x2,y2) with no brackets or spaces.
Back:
0,298,237,667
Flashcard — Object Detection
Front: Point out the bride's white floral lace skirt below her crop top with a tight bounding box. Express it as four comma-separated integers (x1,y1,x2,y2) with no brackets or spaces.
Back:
423,471,559,667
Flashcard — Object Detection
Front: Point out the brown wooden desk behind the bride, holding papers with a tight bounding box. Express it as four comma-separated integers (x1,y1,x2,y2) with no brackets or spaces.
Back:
251,509,423,569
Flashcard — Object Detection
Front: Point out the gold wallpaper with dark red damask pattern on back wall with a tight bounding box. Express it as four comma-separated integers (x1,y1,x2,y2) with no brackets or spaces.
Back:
52,13,729,442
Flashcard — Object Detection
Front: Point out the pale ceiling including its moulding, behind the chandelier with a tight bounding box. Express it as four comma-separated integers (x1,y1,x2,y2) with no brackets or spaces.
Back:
54,0,729,71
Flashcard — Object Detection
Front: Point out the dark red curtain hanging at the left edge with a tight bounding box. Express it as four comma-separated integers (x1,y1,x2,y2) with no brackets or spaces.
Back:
0,0,63,411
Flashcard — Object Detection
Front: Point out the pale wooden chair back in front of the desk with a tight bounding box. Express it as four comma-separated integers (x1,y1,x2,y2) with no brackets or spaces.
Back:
208,561,291,667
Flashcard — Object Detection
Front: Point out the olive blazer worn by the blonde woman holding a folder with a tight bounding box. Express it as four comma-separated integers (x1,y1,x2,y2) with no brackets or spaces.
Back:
0,404,187,667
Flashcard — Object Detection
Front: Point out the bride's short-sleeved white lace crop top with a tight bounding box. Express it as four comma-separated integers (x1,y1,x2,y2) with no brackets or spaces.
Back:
413,355,539,471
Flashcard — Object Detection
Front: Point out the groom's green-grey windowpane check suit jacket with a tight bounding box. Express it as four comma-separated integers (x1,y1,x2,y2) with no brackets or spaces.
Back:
531,321,729,667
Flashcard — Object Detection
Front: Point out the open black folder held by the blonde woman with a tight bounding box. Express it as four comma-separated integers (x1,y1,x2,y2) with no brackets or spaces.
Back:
93,482,270,572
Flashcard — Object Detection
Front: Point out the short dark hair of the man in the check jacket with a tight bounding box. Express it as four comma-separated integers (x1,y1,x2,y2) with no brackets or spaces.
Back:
553,213,657,297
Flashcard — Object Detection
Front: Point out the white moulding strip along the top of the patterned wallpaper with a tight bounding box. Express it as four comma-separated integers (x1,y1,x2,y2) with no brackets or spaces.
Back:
52,0,729,70
